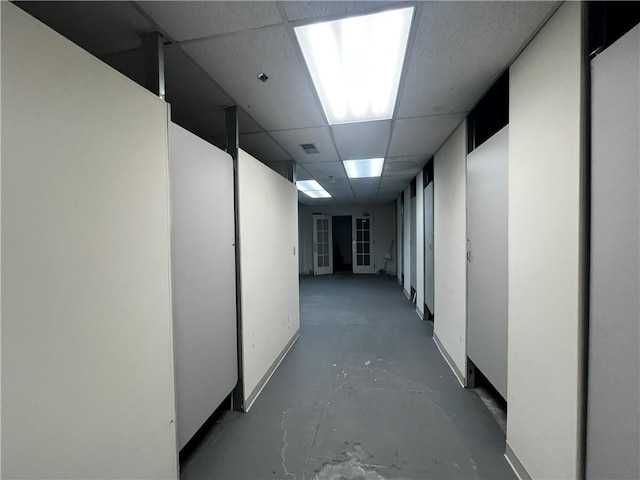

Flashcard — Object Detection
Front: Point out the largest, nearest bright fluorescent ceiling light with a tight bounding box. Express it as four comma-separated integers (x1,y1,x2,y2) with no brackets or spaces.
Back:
295,7,414,125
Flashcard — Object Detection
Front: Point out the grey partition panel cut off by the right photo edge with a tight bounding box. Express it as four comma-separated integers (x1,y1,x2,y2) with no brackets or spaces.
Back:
586,26,640,479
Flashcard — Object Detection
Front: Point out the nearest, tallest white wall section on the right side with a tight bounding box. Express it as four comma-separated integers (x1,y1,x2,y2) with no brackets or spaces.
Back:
504,2,584,478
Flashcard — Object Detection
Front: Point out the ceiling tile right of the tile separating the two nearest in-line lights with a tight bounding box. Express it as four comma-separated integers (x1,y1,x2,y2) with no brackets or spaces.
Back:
389,114,464,157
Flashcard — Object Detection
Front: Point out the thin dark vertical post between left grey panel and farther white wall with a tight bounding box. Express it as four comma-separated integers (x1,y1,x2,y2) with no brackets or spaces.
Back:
224,105,245,412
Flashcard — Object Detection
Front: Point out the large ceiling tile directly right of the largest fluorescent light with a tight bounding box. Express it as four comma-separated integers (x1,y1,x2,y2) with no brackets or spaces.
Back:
398,1,557,118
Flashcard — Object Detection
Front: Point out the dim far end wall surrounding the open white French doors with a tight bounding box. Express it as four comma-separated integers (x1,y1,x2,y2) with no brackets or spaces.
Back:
300,204,397,274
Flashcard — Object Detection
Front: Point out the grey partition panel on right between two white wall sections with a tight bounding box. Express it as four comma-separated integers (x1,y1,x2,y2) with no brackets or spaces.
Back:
467,127,509,398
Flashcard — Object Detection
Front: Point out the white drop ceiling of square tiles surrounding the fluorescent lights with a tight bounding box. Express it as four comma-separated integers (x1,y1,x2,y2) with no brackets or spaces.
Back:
16,1,558,205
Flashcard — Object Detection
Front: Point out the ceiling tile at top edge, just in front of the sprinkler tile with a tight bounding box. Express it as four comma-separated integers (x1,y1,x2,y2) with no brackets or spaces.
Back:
137,1,282,42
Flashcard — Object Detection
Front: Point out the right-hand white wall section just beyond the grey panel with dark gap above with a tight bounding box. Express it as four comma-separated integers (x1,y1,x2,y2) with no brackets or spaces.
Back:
433,122,467,383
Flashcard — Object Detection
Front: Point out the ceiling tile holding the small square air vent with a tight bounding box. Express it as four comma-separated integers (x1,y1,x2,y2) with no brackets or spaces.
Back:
270,127,340,163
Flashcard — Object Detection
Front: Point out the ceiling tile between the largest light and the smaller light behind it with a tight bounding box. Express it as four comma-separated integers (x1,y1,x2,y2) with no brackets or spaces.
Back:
331,120,391,160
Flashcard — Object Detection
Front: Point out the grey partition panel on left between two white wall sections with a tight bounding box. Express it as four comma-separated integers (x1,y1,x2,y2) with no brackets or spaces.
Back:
169,123,238,449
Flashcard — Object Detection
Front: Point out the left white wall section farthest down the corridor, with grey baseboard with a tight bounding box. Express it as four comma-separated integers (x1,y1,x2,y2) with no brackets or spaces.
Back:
237,150,300,410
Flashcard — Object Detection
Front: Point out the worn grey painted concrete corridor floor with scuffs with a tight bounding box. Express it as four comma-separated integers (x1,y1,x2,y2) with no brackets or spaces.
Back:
181,275,515,480
